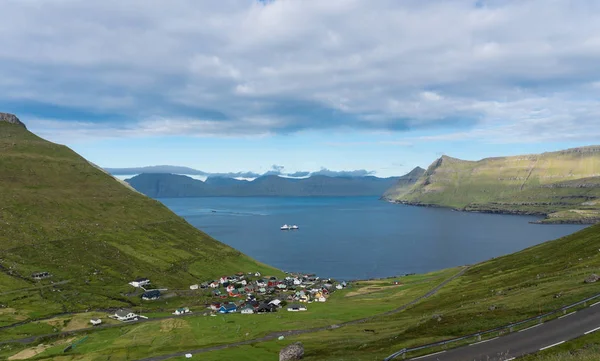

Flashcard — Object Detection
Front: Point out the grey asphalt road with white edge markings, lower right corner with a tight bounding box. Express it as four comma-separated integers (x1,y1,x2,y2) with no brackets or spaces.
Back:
395,304,600,361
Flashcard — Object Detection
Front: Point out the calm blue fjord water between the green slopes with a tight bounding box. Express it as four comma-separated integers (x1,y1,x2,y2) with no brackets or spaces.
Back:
160,197,583,280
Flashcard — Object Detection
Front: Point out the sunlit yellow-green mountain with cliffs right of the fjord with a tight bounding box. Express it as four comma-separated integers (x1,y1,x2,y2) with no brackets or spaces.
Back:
387,146,600,223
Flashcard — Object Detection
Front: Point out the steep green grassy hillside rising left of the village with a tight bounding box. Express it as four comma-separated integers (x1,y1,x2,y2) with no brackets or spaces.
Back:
0,122,279,325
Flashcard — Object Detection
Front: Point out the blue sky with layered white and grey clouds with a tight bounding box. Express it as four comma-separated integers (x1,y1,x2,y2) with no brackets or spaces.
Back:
0,0,600,176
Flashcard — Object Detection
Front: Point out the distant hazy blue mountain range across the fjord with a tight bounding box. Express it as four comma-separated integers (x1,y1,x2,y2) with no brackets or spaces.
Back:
126,174,398,198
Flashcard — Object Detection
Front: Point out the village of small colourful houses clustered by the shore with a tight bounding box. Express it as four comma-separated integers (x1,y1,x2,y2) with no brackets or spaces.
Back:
103,272,348,326
